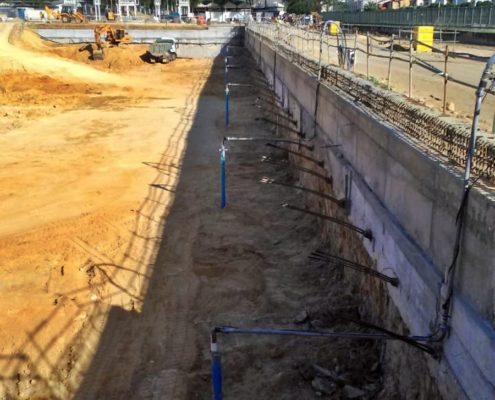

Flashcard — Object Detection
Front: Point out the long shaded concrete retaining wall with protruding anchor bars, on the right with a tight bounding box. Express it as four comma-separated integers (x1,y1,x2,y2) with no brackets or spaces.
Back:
245,30,495,399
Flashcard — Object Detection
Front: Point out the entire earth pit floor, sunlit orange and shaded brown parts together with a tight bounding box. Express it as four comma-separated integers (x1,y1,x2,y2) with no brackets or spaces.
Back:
0,25,435,400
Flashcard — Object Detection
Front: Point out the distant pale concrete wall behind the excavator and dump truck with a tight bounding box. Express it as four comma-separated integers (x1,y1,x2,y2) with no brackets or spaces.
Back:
37,26,244,58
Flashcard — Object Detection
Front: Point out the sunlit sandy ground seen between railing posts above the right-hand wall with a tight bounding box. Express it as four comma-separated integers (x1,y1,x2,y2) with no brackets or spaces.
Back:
292,35,495,133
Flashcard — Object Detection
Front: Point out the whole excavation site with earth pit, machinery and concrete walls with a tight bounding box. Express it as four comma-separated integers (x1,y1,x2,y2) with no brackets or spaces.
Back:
0,17,495,400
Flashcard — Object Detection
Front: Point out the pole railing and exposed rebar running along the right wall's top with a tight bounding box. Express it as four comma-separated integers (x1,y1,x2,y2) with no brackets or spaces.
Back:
247,22,495,181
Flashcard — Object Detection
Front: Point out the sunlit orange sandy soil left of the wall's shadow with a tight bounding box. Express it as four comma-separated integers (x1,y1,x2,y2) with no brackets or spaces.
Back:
0,24,211,398
